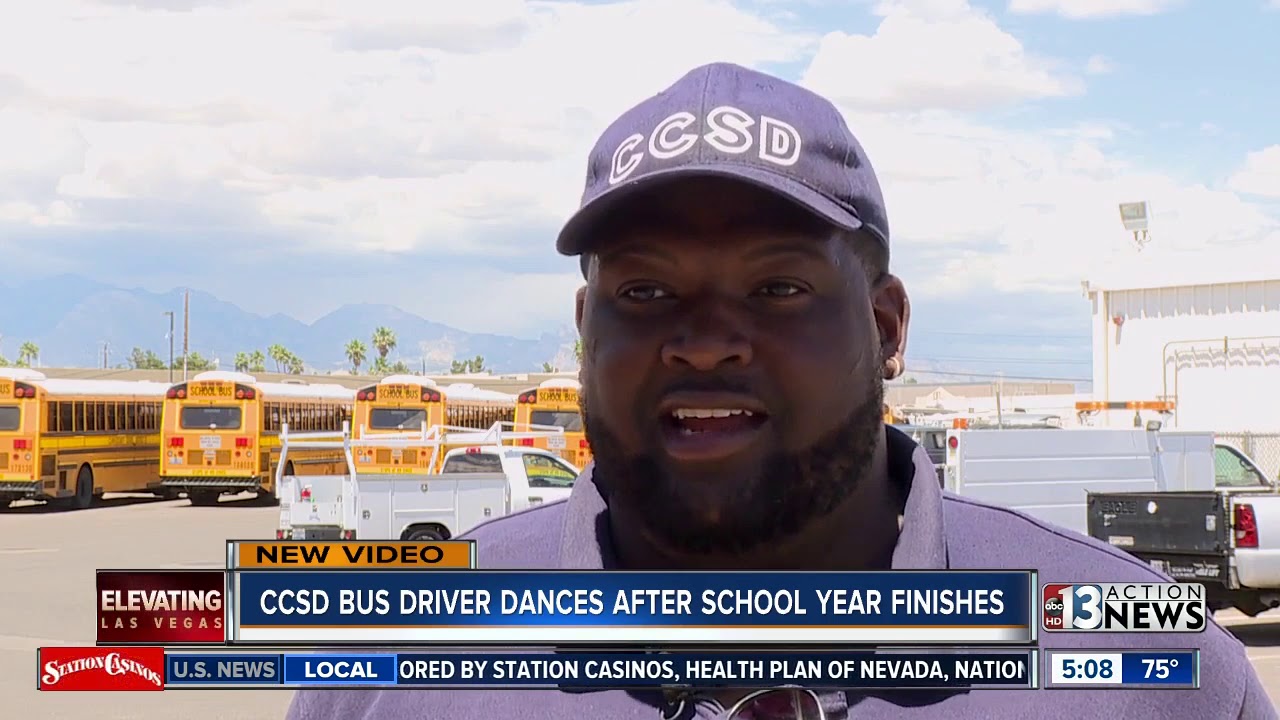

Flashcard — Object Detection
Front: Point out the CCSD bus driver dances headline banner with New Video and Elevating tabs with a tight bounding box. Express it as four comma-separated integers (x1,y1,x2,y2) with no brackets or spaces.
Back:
97,541,1042,648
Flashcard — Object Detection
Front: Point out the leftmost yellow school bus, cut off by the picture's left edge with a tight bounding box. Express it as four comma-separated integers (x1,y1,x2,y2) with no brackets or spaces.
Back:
0,368,169,509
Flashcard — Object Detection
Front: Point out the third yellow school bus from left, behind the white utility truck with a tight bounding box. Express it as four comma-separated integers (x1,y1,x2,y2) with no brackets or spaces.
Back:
352,375,516,475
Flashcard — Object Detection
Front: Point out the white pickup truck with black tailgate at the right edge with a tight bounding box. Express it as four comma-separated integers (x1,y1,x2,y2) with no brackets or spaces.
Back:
1089,445,1280,616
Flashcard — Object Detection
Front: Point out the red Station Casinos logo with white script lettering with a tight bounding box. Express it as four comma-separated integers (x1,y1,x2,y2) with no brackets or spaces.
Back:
37,647,164,692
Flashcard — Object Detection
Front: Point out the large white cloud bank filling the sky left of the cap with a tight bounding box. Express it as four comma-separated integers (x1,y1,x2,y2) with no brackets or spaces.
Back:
0,0,810,252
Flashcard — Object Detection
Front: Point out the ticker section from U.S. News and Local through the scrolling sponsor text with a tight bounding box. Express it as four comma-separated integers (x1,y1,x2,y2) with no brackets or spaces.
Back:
164,648,1039,691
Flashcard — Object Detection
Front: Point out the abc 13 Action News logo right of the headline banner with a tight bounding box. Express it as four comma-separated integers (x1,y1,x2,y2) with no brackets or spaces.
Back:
1041,583,1208,633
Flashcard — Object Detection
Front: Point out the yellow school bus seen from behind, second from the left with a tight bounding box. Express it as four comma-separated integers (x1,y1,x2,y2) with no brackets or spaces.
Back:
160,370,355,505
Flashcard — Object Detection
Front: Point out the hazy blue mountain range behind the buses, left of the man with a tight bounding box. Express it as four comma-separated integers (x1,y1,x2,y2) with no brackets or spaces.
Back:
0,275,576,373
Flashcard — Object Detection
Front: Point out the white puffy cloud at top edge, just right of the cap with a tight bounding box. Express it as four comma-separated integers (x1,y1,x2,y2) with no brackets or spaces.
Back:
804,0,1083,110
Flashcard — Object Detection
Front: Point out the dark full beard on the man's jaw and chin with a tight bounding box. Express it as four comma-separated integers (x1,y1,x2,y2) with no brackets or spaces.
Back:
581,363,884,555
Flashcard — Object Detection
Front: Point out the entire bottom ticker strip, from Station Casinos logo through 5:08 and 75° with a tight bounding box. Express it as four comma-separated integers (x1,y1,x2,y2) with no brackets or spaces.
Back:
37,647,1199,692
